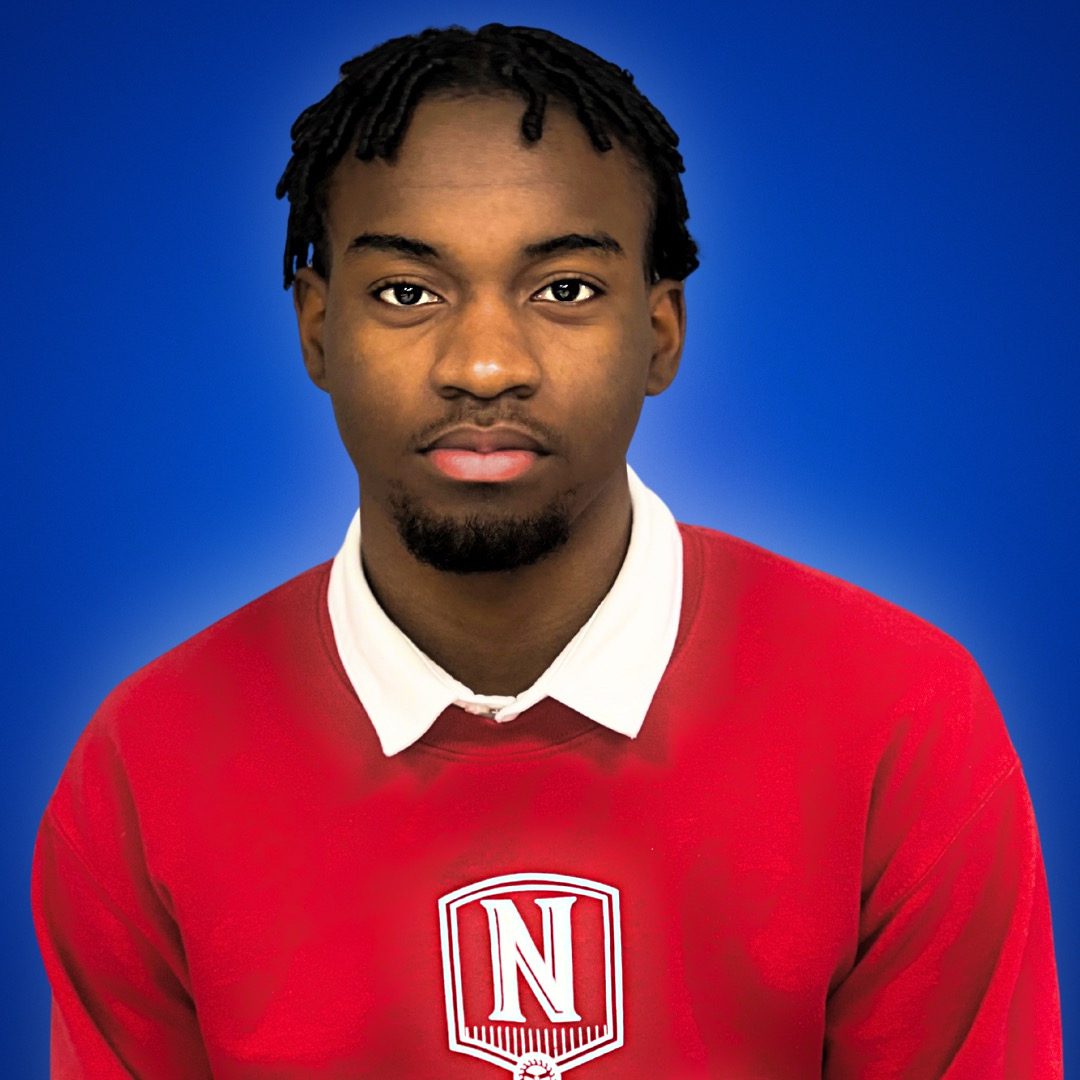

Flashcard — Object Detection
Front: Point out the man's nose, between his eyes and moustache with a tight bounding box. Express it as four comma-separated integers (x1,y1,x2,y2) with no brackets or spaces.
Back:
431,297,540,400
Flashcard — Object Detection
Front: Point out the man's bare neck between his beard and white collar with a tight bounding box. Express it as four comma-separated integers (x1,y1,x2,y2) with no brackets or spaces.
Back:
361,473,631,694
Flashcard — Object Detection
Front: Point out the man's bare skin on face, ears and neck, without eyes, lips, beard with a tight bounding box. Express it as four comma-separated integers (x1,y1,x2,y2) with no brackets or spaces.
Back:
294,95,685,694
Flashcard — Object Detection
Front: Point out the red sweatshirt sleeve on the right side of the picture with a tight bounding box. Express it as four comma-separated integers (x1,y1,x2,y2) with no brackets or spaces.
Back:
823,648,1063,1080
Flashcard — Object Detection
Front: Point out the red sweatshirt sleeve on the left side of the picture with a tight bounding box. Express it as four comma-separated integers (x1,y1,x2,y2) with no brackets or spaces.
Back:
31,712,211,1080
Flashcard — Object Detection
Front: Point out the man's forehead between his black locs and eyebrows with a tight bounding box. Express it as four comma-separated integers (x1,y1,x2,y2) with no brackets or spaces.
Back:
327,95,650,260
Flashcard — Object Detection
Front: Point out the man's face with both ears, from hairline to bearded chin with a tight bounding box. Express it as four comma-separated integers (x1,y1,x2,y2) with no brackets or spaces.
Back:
295,90,683,570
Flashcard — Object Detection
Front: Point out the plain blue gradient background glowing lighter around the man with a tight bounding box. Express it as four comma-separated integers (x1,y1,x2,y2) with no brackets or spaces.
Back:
0,0,1080,1077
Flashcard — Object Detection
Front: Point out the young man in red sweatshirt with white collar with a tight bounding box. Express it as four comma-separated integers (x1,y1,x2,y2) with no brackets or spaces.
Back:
33,19,1061,1080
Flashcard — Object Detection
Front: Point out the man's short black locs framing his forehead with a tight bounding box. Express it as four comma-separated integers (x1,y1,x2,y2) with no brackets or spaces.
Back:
278,23,698,288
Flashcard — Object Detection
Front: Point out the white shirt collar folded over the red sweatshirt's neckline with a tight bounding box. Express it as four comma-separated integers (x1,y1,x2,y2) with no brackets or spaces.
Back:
327,465,683,757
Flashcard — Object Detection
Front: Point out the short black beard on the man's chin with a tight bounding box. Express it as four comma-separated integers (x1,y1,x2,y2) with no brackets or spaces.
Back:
391,491,571,573
